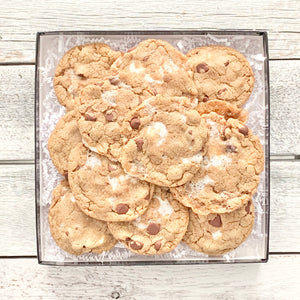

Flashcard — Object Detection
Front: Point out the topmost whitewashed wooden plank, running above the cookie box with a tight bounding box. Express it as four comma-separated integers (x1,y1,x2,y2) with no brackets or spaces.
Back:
0,0,300,62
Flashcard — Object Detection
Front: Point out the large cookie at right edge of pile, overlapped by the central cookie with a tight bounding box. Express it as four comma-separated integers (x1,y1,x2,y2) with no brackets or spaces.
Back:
171,112,264,215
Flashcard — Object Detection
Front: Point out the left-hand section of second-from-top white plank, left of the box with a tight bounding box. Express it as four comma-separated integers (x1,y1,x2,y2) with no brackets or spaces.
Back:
0,66,34,160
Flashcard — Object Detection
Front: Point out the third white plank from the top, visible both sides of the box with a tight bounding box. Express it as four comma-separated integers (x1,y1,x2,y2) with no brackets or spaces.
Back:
0,161,300,256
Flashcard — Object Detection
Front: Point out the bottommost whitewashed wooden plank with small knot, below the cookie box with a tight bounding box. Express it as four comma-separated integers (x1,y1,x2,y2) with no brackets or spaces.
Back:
0,255,300,300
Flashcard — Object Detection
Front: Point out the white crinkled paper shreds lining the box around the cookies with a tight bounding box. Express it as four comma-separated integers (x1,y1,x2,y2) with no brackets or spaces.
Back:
37,33,268,264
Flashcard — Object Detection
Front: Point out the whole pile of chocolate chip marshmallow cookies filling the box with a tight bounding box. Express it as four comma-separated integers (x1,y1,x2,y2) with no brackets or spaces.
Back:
48,40,264,255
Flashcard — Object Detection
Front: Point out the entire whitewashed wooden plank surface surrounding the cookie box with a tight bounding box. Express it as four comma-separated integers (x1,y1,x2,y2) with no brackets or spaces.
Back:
0,0,300,299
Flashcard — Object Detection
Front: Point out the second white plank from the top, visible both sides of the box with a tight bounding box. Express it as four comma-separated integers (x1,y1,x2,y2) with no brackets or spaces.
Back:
0,60,300,160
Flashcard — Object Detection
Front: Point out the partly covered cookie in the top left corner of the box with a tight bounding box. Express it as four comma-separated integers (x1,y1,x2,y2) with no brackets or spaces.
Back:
53,43,121,110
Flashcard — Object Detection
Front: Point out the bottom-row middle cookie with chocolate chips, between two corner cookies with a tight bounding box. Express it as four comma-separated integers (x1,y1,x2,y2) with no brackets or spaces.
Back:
108,186,189,255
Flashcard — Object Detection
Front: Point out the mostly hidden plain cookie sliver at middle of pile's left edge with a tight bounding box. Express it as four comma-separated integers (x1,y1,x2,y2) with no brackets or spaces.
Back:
48,111,81,176
